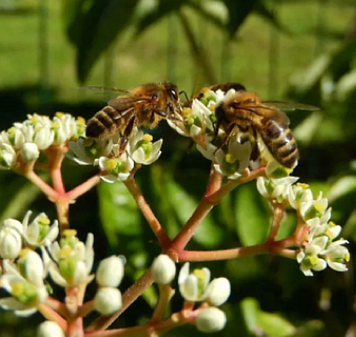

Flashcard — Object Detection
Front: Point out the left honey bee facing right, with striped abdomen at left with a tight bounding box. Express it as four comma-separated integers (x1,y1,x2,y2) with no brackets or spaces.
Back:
83,82,181,153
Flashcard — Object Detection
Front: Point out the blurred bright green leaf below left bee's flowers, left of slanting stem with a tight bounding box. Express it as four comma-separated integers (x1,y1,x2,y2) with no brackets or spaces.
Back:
98,182,142,247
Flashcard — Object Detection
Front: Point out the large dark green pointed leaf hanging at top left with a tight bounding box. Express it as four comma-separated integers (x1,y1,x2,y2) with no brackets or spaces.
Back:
64,0,139,82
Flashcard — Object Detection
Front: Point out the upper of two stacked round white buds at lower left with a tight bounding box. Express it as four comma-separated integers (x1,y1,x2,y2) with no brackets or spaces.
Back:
96,256,124,288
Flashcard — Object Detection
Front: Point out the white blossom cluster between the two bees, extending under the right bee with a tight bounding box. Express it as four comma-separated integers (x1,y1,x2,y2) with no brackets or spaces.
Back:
168,89,290,179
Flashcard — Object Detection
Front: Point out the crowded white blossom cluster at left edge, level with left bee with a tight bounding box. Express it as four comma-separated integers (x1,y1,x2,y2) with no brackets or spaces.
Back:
0,112,85,169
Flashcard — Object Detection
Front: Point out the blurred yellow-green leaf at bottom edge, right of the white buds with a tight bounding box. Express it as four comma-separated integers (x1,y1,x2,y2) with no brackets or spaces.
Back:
258,312,296,337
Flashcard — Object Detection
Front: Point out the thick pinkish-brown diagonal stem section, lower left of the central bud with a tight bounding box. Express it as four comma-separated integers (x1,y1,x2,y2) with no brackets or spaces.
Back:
87,269,153,330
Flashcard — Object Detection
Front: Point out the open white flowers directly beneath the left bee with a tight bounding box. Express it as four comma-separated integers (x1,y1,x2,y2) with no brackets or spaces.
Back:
67,128,163,183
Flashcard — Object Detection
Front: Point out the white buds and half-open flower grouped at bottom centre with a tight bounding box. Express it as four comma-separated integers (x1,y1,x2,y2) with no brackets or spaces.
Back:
152,254,231,332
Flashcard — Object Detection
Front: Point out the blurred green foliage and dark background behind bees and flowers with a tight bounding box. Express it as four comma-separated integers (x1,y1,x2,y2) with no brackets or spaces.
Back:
0,0,356,337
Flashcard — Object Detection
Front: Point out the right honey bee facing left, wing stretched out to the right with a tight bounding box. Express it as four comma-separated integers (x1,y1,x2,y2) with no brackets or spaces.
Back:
215,89,318,168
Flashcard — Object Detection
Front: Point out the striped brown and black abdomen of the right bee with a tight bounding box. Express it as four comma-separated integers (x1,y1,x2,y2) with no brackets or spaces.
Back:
260,120,299,168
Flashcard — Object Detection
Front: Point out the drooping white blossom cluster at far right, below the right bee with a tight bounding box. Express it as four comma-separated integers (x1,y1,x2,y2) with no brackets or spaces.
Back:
257,177,350,276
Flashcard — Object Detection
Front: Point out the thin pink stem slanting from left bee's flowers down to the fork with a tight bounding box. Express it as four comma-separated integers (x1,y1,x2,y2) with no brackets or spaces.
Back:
124,176,171,248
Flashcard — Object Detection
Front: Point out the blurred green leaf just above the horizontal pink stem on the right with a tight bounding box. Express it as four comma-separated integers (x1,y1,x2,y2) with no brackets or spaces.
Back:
235,184,270,246
